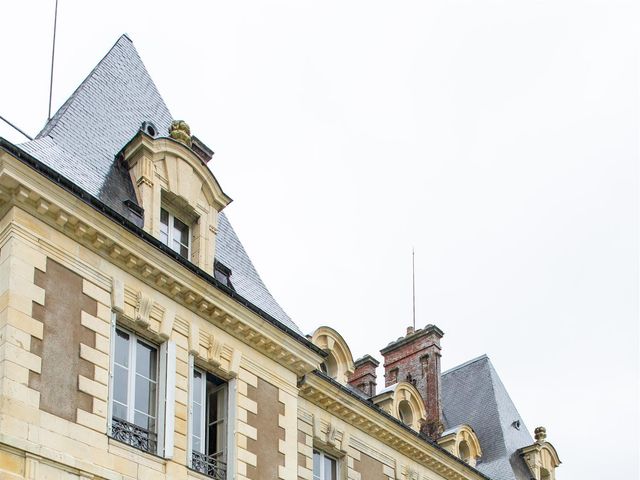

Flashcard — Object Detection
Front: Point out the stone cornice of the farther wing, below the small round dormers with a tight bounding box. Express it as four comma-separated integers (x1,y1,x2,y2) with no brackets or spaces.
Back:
299,371,487,480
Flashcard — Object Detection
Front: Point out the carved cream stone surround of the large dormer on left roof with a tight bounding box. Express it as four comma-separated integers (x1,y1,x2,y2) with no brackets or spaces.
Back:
121,122,231,273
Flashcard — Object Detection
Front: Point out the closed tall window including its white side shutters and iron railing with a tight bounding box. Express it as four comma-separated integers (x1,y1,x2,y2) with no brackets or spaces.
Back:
108,322,176,458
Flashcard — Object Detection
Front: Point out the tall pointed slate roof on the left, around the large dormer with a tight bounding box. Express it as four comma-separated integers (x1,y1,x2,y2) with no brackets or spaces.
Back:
20,35,302,335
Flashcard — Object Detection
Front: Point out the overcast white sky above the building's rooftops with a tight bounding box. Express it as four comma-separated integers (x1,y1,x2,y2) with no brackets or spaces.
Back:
0,0,639,479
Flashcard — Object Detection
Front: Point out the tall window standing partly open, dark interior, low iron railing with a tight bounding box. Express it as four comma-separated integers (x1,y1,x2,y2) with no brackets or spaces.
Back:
190,368,227,480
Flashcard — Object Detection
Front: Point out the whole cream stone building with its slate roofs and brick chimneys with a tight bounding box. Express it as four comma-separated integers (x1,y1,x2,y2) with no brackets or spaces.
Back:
0,36,559,480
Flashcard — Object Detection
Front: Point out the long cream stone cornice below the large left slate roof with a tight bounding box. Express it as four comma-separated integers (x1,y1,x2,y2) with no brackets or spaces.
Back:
0,149,322,375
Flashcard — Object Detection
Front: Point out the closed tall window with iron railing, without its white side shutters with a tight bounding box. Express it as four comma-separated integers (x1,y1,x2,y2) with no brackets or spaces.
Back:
111,328,158,453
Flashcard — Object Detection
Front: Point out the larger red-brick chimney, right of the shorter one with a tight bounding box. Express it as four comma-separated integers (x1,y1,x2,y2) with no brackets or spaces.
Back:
380,325,444,440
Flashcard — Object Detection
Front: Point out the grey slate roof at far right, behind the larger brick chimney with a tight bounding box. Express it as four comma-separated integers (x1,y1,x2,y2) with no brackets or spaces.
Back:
442,355,533,480
